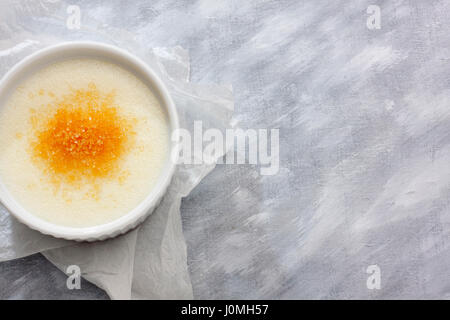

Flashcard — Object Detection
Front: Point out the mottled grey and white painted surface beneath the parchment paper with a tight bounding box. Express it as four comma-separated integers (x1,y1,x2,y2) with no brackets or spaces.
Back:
0,0,450,299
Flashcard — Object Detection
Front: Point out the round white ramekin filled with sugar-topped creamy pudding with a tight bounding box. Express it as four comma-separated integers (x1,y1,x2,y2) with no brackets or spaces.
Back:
0,42,178,241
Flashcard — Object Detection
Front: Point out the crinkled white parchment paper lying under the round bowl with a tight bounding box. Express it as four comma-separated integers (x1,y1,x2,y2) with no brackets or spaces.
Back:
0,2,233,299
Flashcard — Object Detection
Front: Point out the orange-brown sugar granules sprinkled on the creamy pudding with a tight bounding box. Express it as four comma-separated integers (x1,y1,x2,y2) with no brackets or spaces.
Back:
31,83,134,181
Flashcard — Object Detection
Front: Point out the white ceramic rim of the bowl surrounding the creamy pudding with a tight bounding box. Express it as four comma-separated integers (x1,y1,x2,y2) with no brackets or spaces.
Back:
0,42,179,241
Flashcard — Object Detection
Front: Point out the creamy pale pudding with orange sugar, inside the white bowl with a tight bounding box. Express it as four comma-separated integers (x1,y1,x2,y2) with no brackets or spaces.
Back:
0,59,169,227
